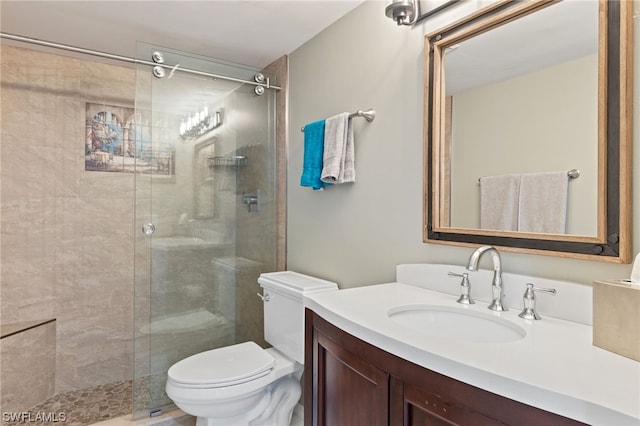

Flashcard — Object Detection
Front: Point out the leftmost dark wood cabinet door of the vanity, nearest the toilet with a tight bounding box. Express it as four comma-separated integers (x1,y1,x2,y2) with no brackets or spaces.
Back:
313,330,389,426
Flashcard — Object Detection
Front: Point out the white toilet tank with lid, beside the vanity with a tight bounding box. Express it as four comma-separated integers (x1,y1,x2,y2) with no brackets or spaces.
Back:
258,271,338,364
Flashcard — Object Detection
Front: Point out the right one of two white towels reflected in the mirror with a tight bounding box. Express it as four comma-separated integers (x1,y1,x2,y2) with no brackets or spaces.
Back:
518,171,569,234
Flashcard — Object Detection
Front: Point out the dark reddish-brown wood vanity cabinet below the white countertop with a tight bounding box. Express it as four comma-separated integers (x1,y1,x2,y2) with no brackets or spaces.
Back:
304,310,582,426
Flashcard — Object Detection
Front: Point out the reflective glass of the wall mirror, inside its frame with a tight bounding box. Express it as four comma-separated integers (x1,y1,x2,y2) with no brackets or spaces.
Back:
444,1,598,236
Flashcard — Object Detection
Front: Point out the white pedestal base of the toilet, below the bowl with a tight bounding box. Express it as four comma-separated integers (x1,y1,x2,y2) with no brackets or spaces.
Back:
196,376,302,426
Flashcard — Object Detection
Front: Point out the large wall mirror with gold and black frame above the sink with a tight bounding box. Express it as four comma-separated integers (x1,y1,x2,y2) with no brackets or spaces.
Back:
423,0,633,263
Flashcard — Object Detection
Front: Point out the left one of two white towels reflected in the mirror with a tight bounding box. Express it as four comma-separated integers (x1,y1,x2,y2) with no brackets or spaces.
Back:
480,175,520,231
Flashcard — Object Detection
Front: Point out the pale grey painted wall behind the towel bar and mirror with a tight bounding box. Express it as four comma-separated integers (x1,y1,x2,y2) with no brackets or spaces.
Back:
287,0,640,288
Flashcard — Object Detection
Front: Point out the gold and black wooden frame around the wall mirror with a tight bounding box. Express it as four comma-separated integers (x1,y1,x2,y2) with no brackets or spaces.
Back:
423,0,633,263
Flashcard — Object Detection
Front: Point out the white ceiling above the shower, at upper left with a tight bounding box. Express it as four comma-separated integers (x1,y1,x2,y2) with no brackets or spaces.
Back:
0,0,364,68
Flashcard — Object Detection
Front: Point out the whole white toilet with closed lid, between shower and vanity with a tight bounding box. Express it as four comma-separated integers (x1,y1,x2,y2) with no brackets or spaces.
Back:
166,271,338,426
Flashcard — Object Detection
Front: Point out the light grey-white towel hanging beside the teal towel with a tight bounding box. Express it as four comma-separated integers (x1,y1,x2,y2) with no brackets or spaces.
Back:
320,112,356,183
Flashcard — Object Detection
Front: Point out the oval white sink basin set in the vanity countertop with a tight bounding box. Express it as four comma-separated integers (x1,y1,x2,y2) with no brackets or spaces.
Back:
387,305,527,343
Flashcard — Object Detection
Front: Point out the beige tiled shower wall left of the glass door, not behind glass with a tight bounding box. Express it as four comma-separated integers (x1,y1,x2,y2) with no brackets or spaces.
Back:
0,45,135,396
